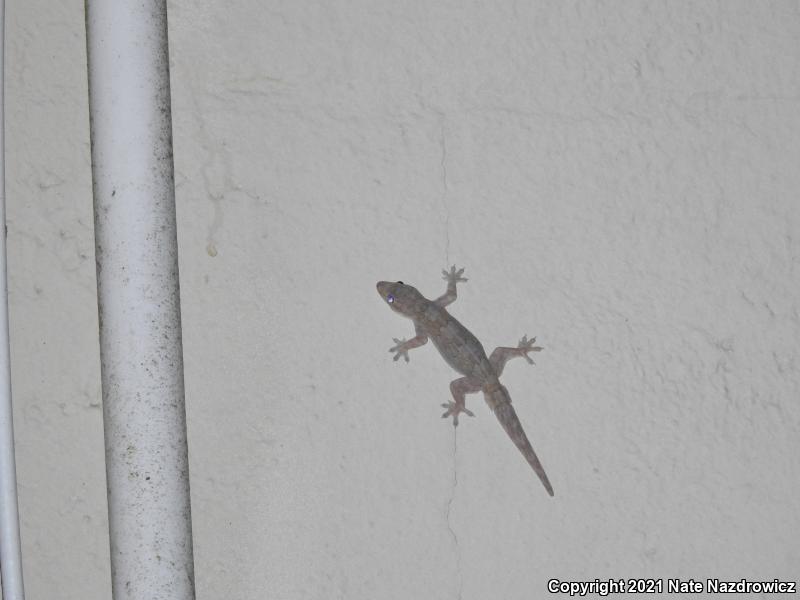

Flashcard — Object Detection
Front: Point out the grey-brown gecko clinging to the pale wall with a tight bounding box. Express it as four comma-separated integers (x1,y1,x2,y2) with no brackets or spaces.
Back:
377,265,553,496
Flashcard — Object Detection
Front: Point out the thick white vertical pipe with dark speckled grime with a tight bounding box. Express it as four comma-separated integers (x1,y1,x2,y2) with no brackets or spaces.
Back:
86,0,194,600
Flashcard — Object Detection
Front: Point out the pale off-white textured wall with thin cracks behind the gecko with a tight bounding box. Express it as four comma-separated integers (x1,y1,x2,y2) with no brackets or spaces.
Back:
6,0,800,600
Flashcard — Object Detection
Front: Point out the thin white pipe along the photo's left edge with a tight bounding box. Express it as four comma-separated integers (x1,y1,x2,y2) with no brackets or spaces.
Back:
0,0,25,600
